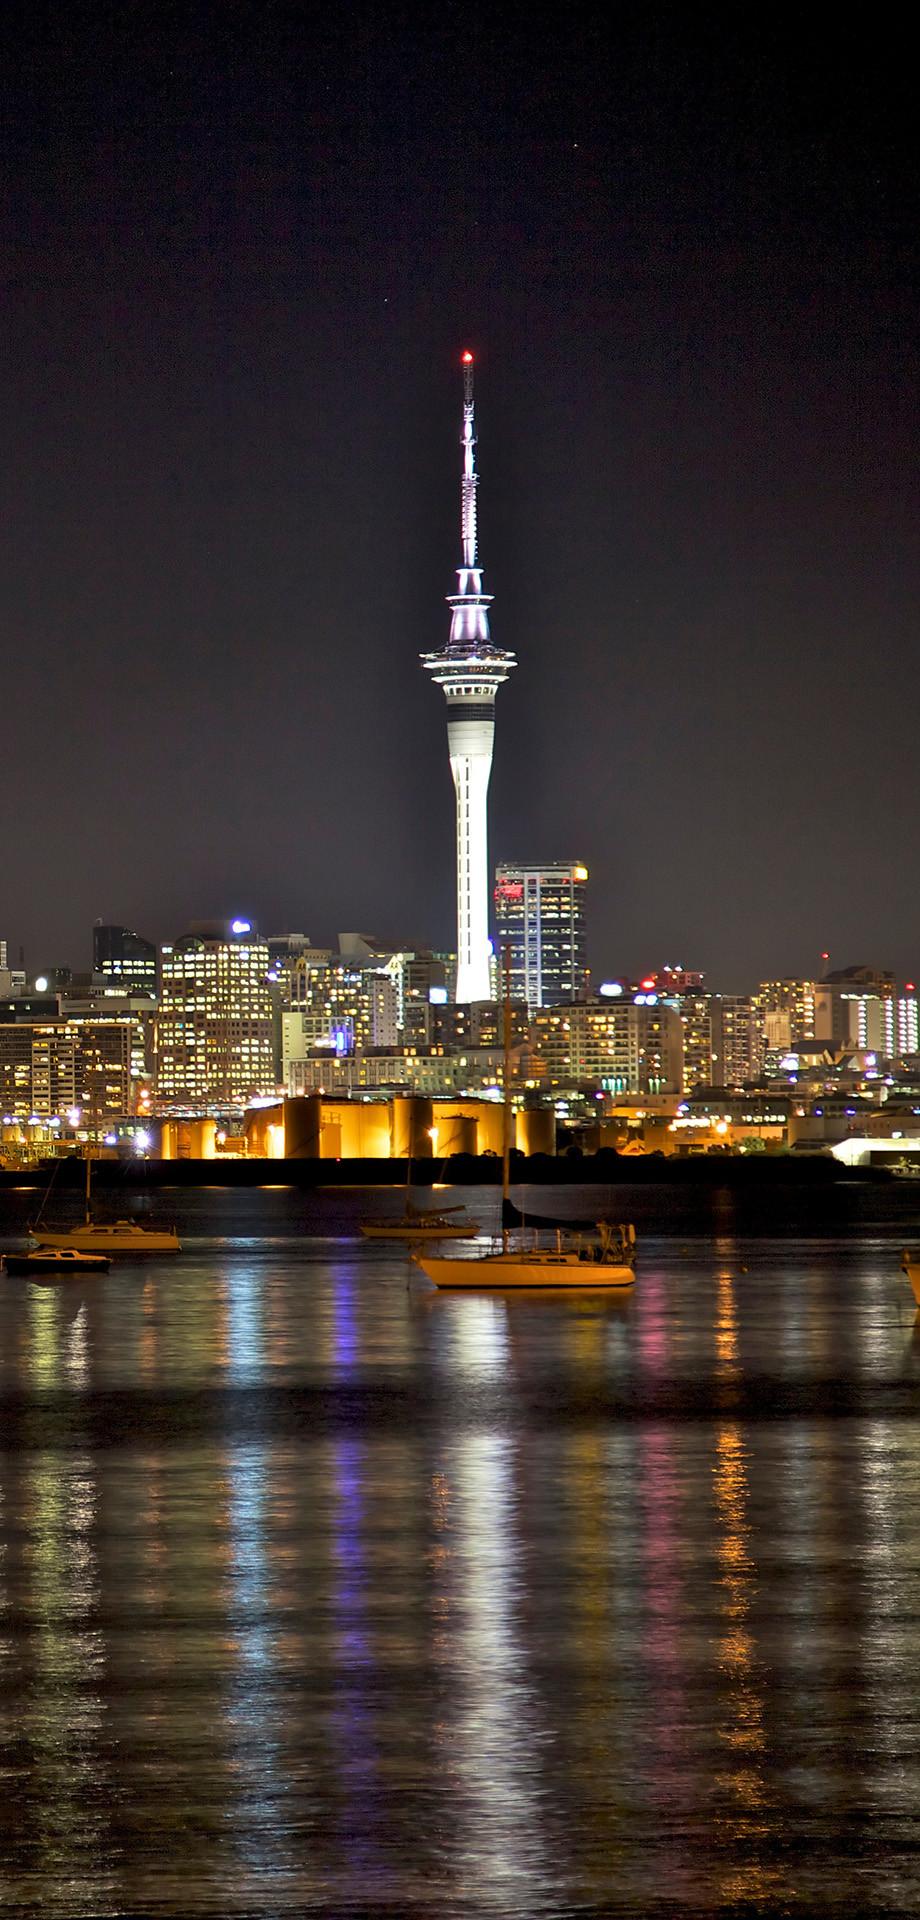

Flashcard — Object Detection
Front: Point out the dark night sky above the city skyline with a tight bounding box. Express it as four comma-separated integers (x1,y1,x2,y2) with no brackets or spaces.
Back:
0,0,920,991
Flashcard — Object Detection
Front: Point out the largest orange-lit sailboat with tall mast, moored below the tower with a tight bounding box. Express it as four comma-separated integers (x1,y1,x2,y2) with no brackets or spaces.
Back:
413,948,636,1288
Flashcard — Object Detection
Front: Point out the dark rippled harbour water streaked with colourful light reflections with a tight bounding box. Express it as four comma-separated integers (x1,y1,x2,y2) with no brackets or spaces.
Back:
0,1190,920,1920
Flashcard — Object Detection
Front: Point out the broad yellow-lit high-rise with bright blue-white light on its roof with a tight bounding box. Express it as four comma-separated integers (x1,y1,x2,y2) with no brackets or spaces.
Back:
156,920,275,1110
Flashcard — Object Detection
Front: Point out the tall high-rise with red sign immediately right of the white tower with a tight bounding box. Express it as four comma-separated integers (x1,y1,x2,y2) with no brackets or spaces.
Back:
496,862,588,1010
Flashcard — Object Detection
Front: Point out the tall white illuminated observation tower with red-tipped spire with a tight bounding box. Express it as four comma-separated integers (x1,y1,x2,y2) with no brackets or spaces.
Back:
421,353,517,1000
